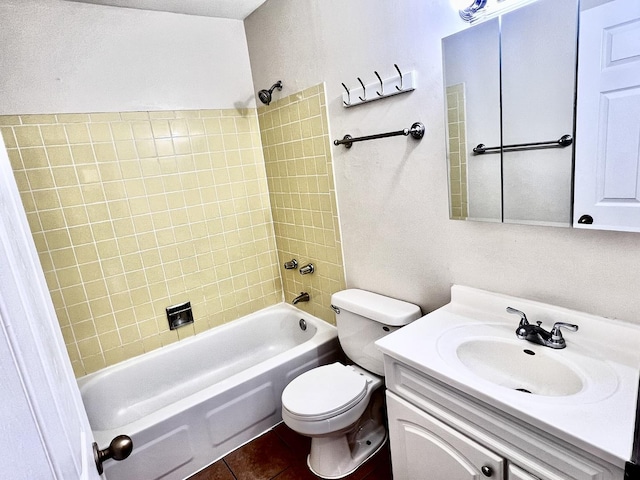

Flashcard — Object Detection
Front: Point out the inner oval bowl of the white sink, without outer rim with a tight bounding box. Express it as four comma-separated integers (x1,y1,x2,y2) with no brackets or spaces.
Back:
456,339,584,397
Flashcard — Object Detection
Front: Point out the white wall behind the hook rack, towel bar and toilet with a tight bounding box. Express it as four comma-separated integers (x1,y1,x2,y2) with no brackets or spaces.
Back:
245,0,640,323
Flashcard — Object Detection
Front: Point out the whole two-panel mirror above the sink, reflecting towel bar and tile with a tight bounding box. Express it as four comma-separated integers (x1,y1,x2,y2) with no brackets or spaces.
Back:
442,0,578,226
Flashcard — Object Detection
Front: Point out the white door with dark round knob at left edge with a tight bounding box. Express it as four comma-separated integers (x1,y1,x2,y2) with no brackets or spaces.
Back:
0,137,105,480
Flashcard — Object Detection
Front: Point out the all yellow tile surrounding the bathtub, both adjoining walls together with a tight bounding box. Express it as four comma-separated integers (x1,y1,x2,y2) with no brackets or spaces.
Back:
0,92,344,375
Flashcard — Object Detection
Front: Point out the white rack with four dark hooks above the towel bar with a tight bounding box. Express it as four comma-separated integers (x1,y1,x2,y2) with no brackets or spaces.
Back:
342,63,416,108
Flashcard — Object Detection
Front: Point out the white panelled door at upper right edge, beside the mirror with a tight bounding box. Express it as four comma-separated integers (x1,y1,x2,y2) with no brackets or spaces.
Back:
573,0,640,232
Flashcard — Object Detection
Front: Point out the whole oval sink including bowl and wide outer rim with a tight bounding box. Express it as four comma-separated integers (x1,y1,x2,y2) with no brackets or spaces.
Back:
437,324,618,404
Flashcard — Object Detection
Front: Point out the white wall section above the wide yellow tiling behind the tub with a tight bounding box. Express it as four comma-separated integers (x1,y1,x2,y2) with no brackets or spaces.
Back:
0,0,255,115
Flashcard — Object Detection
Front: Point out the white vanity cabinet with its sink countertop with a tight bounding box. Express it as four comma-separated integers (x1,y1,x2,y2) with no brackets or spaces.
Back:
376,285,640,480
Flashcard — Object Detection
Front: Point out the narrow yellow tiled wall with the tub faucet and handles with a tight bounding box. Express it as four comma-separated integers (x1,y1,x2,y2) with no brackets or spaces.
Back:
258,84,345,324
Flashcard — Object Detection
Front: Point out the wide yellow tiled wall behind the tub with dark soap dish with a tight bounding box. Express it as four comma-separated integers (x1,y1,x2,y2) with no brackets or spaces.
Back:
0,109,280,376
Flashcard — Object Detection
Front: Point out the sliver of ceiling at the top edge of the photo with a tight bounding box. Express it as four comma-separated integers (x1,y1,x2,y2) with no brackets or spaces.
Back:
62,0,266,20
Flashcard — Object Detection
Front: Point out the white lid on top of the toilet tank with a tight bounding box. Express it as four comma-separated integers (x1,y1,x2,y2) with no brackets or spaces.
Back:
331,288,422,327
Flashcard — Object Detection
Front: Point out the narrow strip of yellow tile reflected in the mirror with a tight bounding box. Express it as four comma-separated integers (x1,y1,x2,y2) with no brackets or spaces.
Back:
447,83,469,220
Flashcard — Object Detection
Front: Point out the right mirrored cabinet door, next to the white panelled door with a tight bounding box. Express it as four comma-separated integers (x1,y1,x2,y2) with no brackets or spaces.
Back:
501,0,578,226
